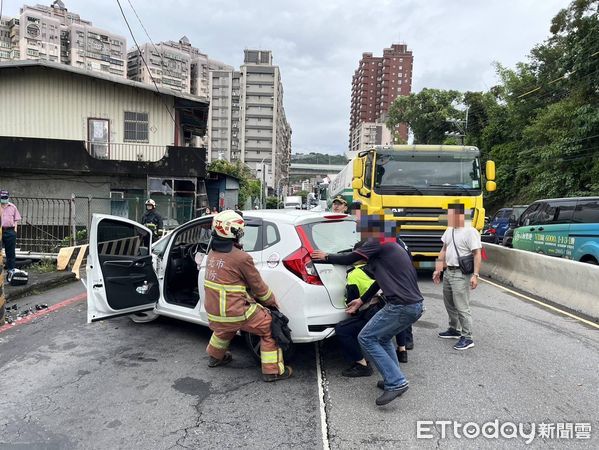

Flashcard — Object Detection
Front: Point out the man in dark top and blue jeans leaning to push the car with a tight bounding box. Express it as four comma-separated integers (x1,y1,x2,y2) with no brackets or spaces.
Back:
312,214,424,406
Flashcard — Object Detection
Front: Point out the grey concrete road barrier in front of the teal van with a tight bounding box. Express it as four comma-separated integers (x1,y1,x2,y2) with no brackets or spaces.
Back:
481,244,599,321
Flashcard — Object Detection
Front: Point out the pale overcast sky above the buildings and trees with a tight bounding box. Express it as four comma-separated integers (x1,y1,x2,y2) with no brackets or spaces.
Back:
4,0,569,153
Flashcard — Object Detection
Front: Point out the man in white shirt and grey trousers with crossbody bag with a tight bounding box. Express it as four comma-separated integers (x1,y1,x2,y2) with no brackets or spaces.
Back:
433,204,482,350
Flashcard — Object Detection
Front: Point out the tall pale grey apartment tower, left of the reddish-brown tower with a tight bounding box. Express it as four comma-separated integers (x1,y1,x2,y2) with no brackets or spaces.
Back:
208,50,291,193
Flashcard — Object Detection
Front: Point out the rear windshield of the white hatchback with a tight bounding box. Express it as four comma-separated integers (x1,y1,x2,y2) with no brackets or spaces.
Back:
302,220,360,253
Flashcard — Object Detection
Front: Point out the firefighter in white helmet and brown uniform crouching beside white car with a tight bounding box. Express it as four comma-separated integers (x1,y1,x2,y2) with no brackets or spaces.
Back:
204,210,293,382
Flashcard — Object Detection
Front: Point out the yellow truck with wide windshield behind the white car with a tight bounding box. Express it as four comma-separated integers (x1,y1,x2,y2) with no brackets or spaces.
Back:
338,145,496,269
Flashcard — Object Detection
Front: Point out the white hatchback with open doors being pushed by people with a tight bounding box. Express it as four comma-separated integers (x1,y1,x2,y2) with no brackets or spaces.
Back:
86,210,359,356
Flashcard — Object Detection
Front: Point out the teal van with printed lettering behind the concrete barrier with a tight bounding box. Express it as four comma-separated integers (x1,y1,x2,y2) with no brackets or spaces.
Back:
513,197,599,264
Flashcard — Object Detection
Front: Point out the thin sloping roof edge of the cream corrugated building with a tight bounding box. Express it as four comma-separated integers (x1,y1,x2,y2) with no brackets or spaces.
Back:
0,60,210,105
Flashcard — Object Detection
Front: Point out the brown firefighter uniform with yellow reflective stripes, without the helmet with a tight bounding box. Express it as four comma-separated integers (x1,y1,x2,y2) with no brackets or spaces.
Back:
204,247,285,375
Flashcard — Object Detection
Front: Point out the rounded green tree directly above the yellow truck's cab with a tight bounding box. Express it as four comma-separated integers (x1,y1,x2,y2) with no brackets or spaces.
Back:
387,88,464,144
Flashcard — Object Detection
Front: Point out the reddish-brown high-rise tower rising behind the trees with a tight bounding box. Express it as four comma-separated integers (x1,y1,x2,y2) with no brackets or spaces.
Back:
348,44,414,156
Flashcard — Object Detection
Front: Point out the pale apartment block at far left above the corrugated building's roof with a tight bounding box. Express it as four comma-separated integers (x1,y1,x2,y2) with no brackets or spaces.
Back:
0,0,127,77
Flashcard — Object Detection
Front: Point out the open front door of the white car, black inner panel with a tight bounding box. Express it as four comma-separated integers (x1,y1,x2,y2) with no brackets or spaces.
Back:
87,214,160,323
